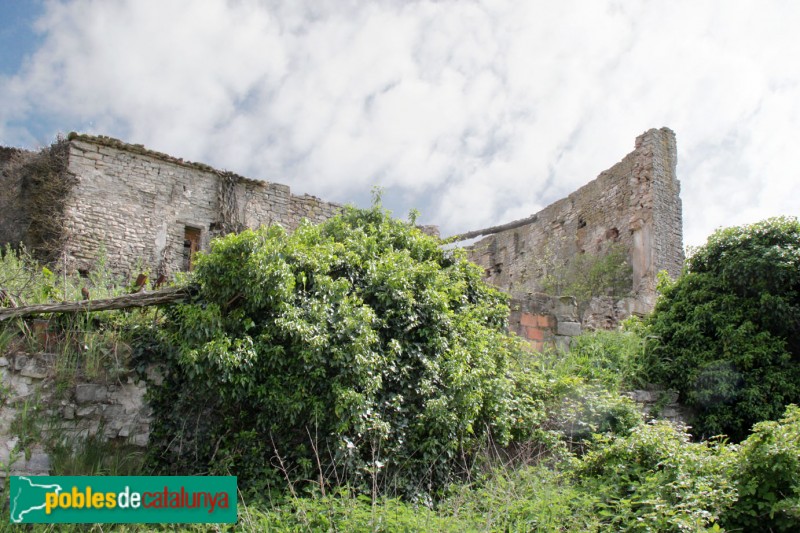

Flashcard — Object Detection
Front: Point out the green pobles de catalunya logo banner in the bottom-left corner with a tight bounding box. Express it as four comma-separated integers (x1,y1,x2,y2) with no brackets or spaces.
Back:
9,476,237,524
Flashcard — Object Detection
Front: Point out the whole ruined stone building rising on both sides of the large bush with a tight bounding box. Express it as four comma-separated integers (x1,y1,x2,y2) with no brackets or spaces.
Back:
0,128,683,343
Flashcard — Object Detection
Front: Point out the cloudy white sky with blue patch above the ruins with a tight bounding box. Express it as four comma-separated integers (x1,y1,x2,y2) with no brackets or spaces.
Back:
0,0,800,246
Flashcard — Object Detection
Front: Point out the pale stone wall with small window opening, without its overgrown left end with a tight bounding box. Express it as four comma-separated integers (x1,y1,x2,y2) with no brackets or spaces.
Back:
60,135,340,274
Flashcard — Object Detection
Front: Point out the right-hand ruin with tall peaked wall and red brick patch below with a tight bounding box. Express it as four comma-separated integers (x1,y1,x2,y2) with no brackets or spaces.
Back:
462,128,684,348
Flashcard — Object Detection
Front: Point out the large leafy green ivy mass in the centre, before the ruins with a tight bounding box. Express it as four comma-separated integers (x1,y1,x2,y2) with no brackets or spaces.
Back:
145,206,514,495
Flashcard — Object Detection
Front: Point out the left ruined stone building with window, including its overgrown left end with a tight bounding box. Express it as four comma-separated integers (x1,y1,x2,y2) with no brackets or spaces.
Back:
0,133,340,275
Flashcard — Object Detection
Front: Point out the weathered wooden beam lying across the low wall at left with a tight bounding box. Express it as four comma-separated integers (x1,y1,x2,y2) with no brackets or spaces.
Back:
0,287,189,322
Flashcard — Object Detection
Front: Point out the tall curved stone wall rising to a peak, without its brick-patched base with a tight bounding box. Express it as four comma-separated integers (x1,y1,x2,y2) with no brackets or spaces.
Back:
468,128,683,314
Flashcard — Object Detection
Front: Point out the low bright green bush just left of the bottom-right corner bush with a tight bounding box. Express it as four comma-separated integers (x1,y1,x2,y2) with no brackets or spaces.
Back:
573,421,736,531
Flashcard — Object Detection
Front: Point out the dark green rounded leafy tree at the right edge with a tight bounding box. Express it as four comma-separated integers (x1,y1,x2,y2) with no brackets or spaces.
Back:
650,218,800,440
